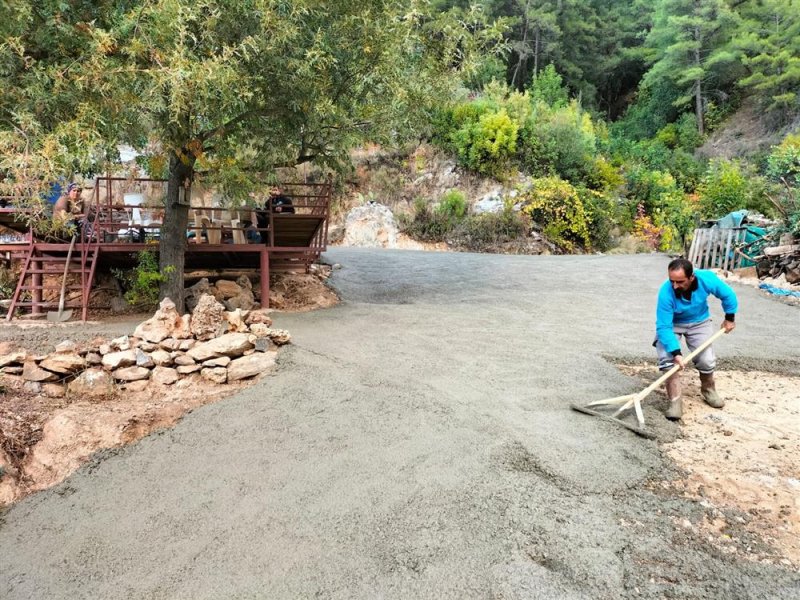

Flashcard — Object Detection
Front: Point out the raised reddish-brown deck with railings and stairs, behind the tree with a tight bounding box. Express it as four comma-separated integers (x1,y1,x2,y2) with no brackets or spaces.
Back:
0,177,332,320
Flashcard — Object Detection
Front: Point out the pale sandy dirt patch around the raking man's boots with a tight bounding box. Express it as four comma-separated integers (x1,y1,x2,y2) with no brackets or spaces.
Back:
620,366,800,567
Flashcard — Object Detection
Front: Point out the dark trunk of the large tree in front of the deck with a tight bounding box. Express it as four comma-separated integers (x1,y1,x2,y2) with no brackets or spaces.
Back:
158,152,194,313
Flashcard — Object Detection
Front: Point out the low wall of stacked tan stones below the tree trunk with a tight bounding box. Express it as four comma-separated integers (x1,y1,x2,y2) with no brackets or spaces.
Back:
0,294,291,397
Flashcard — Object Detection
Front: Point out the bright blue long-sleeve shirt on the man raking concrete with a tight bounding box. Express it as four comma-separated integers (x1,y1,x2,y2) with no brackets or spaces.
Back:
656,269,739,353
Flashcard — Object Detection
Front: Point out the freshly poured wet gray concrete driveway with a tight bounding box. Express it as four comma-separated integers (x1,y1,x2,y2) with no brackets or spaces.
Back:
0,249,800,600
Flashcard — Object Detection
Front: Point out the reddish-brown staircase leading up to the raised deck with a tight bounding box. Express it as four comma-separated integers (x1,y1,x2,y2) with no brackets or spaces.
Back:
6,242,99,321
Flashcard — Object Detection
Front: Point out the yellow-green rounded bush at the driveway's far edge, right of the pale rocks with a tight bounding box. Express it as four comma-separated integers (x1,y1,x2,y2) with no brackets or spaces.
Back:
521,177,591,250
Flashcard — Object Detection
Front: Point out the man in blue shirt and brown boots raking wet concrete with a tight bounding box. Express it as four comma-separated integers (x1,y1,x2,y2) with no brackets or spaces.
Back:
653,258,738,420
